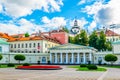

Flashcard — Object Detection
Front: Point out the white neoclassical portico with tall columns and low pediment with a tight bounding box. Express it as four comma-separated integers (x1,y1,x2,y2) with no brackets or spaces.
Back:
50,43,96,64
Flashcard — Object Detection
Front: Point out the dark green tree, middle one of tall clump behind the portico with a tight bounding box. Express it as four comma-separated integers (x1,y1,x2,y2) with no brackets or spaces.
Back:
89,31,98,49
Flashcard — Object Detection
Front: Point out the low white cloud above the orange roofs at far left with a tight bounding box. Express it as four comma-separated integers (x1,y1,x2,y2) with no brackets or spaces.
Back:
0,19,45,34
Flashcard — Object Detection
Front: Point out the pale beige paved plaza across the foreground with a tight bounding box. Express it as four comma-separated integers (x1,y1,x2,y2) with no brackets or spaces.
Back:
0,66,120,80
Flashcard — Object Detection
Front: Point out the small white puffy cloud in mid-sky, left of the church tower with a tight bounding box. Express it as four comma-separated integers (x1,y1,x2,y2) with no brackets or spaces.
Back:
41,16,66,30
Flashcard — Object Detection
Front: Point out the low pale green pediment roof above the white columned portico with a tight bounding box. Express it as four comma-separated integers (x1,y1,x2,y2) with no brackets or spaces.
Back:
49,43,96,50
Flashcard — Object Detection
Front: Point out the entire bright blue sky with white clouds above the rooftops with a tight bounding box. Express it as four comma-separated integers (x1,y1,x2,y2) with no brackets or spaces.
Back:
0,0,120,34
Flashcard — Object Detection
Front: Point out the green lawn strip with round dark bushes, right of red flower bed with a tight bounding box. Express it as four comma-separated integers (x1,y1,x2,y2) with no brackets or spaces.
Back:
69,66,107,71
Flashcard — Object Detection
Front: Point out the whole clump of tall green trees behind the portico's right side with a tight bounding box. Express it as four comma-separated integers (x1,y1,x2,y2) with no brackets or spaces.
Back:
69,30,112,51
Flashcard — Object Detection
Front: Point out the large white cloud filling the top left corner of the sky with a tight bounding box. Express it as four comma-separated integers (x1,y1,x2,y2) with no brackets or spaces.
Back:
0,0,63,18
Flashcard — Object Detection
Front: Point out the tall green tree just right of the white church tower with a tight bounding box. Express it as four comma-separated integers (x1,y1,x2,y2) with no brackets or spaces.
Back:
78,30,89,46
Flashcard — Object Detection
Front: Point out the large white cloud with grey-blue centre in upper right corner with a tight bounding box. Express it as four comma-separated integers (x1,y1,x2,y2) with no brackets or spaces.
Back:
82,0,120,31
